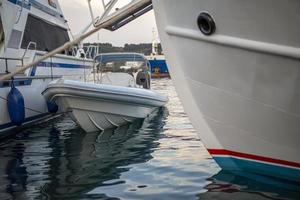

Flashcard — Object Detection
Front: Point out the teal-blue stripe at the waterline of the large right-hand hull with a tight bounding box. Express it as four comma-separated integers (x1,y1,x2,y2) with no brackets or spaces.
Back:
213,156,300,181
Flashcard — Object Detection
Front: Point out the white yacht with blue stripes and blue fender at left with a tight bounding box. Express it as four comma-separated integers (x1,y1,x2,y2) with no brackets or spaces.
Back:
0,0,93,137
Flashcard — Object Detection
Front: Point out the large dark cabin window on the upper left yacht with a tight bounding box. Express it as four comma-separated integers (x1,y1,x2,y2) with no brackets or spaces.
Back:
21,15,70,51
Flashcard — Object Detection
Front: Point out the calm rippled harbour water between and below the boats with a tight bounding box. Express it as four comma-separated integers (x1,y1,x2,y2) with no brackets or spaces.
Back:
0,79,300,200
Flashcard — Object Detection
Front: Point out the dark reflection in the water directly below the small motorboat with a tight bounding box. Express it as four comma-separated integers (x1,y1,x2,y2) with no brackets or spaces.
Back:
42,109,166,199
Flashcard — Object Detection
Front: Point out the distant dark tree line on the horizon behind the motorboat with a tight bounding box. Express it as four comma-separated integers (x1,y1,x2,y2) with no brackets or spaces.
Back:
83,43,162,55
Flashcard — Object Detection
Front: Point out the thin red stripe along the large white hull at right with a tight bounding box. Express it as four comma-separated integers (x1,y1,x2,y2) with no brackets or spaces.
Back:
207,149,300,168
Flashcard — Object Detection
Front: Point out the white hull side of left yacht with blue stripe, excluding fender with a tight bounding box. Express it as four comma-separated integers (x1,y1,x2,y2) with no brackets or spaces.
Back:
0,57,92,134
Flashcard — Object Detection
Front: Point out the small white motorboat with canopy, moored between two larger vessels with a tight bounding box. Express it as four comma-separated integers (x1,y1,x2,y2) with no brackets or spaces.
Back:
43,53,168,132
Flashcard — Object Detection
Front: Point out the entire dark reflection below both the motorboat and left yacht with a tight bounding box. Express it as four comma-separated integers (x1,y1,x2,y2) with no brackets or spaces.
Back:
0,108,168,199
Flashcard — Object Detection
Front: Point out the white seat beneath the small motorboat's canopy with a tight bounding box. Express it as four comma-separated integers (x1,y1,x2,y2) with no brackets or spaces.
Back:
101,72,135,87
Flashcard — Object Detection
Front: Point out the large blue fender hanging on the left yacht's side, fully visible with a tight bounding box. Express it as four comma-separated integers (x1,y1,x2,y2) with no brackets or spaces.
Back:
7,86,25,126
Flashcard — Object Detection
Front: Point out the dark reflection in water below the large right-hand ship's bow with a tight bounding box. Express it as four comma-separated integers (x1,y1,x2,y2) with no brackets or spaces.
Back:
197,170,300,200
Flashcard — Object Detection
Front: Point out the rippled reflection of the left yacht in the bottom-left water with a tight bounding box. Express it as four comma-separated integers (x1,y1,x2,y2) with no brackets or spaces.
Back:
0,125,55,199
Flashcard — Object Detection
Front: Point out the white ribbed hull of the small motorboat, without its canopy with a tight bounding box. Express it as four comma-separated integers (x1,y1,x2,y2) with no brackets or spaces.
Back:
43,80,167,132
